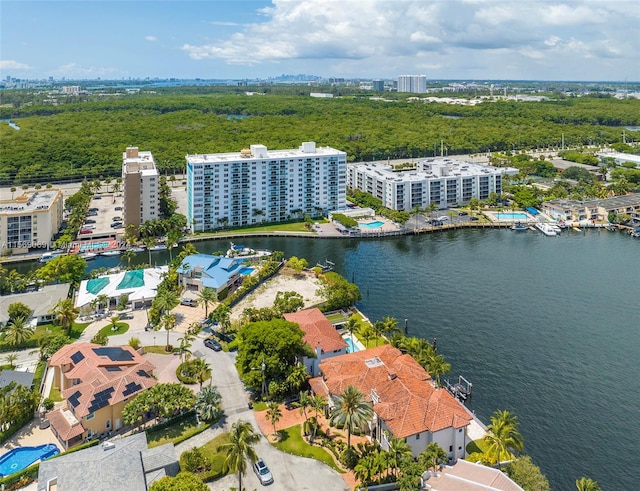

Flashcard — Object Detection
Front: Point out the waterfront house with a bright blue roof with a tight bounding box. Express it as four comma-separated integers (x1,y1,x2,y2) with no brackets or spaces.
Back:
177,254,249,293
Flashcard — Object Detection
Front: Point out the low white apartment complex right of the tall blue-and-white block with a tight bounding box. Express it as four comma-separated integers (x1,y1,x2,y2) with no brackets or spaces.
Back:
347,157,518,211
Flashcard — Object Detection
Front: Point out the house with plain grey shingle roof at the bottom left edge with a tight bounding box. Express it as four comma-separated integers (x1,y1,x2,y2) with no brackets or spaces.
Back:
38,432,180,491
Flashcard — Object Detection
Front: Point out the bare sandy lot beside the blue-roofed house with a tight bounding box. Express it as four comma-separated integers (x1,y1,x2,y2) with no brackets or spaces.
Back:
231,271,323,320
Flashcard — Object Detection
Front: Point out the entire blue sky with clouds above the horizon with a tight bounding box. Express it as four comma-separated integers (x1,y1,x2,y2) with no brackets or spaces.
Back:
0,0,640,81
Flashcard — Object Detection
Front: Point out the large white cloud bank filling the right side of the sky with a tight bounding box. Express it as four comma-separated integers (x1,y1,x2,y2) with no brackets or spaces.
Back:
182,0,640,78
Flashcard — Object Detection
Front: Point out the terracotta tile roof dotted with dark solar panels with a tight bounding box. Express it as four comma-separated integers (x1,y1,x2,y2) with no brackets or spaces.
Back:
49,343,157,418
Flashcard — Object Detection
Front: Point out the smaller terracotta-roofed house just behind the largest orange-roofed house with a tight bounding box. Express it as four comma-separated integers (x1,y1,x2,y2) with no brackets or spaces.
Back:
284,309,347,377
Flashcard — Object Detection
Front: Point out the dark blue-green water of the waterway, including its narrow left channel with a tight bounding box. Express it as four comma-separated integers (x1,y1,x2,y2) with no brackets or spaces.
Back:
12,230,640,491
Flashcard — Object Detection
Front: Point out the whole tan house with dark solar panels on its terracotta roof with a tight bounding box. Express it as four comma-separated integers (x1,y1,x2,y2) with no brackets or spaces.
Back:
46,343,157,449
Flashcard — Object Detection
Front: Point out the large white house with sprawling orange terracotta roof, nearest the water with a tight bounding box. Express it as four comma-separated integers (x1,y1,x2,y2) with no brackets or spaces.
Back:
310,344,473,461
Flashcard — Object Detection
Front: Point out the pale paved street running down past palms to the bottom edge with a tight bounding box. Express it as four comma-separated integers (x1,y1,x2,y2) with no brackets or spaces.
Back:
198,350,349,491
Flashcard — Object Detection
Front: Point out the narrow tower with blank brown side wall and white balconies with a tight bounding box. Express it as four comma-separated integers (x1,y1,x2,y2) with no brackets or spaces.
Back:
122,147,160,227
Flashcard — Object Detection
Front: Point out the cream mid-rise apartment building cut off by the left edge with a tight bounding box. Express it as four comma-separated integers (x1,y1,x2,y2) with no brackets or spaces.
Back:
0,189,64,255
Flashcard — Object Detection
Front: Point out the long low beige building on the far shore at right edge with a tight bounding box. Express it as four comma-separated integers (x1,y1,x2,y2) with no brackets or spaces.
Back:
542,193,640,222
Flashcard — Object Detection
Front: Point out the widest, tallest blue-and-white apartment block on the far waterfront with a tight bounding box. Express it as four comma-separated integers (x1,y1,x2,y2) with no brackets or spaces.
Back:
187,142,347,230
